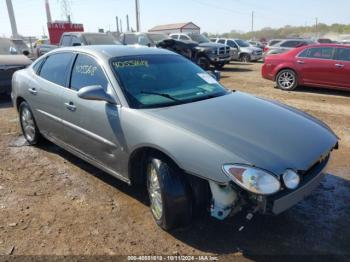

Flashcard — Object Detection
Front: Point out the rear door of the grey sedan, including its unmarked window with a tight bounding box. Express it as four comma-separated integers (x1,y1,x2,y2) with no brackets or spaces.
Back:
28,52,75,140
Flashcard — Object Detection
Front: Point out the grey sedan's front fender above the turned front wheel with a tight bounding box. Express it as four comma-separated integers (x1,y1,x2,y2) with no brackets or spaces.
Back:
121,108,250,184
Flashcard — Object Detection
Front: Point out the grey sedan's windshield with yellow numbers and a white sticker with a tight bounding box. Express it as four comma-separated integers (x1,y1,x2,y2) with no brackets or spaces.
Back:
111,54,228,108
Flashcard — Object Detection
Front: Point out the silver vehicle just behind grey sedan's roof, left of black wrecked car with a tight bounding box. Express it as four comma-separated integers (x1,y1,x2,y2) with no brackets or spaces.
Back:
120,32,170,47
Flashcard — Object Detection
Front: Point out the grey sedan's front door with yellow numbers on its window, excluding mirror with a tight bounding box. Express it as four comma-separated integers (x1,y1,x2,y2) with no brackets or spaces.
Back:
62,54,125,177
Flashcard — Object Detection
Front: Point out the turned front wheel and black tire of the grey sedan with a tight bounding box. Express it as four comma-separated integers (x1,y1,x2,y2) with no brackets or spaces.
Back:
147,157,192,231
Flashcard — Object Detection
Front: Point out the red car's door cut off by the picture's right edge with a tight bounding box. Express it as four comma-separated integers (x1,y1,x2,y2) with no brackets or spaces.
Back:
334,47,350,88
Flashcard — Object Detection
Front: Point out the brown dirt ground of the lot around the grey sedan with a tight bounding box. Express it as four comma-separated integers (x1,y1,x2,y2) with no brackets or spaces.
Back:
0,63,350,260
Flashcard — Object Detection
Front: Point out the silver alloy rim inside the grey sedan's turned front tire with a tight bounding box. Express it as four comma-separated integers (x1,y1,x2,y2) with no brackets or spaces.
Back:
148,163,163,220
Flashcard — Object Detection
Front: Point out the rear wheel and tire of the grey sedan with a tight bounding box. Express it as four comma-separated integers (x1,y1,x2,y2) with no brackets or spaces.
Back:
19,101,41,145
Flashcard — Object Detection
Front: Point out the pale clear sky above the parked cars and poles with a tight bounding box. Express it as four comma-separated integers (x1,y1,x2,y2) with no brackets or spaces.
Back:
0,0,350,36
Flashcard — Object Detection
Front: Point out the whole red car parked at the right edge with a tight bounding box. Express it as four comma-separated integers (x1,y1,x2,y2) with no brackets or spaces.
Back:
262,44,350,90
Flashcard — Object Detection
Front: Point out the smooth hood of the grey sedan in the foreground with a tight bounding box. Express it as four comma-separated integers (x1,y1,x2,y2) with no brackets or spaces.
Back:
149,92,338,175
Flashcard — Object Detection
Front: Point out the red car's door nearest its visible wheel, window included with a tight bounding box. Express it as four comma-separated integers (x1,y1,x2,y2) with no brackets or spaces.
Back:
295,47,338,86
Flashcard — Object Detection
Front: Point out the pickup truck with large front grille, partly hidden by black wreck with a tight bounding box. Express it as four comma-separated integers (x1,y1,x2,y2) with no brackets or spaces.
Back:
170,33,231,70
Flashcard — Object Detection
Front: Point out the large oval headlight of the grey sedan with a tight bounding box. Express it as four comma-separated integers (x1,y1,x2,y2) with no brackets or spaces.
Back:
223,165,281,195
